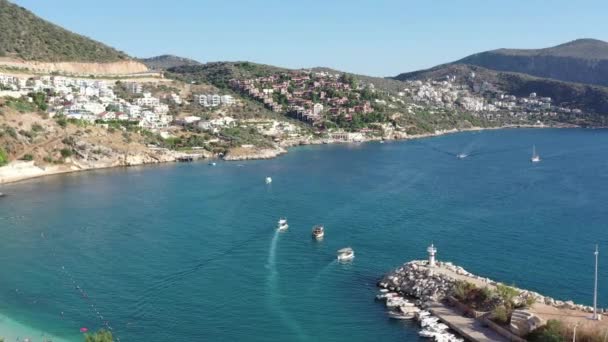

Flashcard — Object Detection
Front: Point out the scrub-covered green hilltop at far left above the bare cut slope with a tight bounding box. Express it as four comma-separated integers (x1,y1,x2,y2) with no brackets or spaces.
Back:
0,0,129,62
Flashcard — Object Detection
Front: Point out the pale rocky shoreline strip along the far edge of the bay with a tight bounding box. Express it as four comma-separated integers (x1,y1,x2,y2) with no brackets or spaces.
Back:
0,125,580,185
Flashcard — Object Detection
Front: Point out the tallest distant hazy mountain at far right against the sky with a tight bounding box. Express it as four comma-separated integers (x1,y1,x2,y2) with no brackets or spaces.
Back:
455,39,608,86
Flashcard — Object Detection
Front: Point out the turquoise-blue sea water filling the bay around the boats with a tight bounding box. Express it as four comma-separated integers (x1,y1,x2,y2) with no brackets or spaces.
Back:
0,129,608,341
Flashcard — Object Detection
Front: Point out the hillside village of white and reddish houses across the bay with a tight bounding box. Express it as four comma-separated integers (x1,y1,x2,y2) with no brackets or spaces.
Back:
0,70,582,152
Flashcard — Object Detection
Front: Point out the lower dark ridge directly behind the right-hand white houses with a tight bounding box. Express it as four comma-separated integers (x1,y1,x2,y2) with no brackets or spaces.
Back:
395,64,608,119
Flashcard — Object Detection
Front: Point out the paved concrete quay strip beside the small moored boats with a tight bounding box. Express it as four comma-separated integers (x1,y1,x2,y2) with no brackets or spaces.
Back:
429,303,509,342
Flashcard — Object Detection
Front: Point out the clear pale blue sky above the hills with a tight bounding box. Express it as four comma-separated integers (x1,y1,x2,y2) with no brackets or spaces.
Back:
12,0,608,76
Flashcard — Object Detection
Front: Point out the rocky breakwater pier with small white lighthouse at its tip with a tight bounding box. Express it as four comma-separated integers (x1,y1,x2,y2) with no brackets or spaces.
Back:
378,245,608,342
